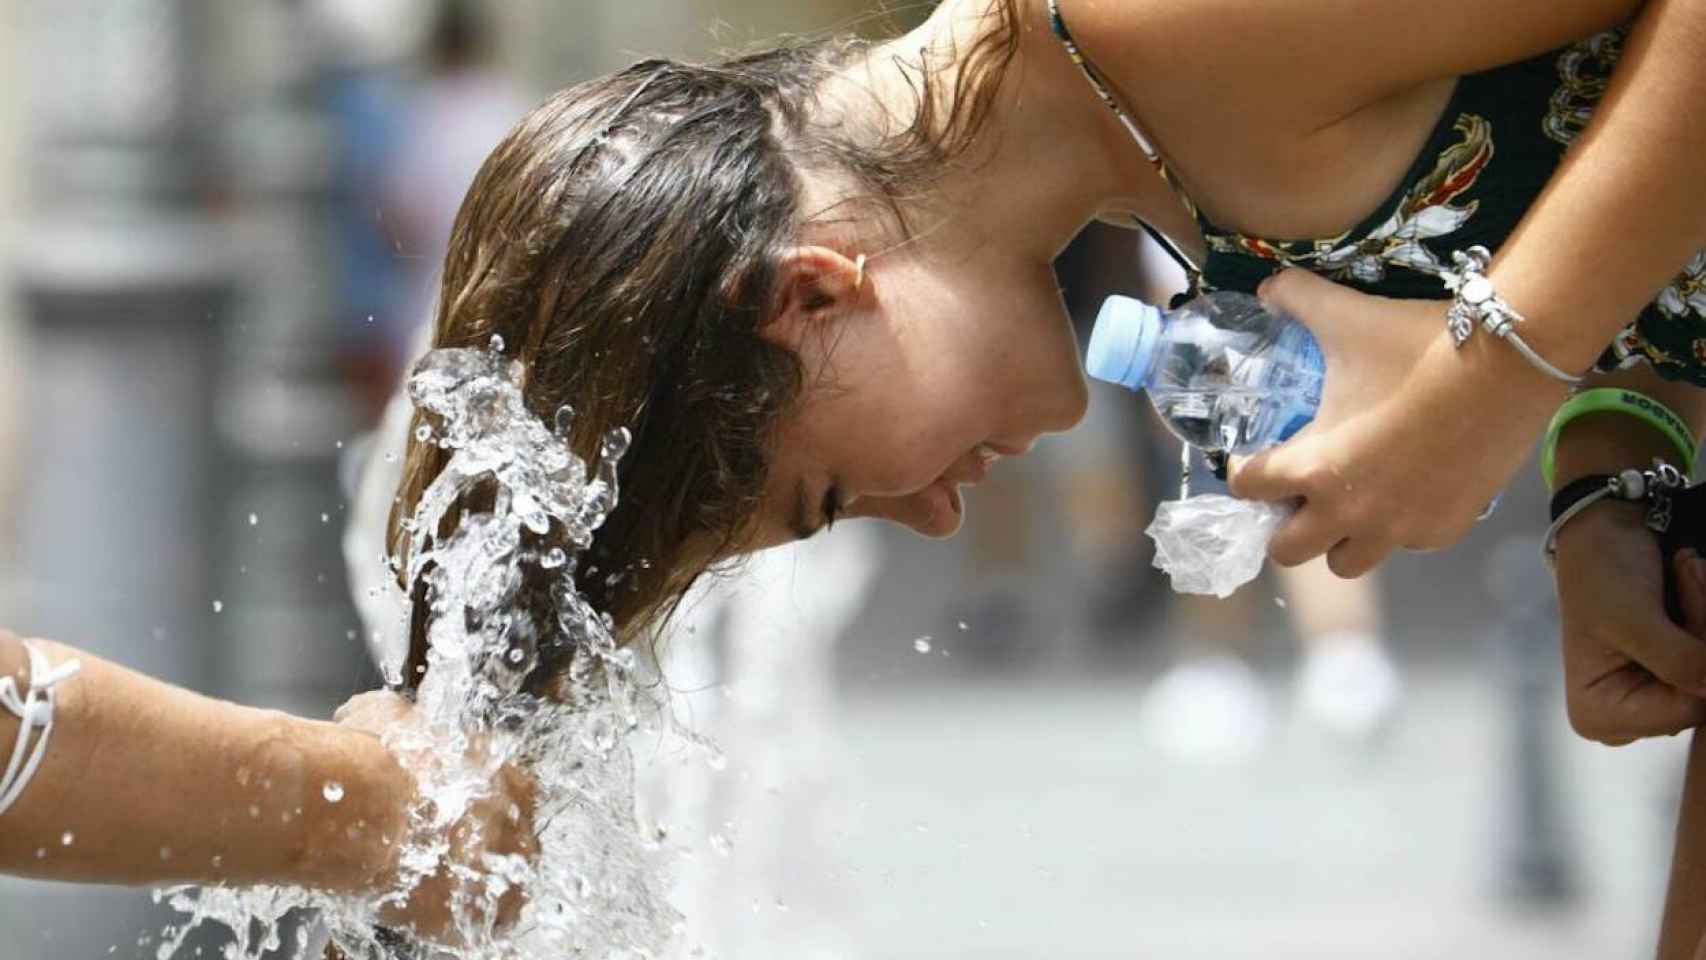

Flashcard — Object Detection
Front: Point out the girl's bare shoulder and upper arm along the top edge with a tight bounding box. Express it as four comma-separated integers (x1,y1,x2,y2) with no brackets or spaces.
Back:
1057,0,1641,114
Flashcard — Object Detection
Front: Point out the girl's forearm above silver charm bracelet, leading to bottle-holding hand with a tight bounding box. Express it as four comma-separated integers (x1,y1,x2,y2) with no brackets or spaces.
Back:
1493,0,1706,370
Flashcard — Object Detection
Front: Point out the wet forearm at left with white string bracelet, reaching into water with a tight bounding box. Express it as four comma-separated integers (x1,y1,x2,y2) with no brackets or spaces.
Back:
0,634,411,888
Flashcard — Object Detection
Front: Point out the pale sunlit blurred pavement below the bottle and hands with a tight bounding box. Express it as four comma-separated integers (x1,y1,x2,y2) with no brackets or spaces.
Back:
678,668,1684,960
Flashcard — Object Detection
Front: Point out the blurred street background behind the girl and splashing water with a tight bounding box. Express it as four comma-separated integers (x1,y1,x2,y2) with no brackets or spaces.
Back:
0,0,1682,960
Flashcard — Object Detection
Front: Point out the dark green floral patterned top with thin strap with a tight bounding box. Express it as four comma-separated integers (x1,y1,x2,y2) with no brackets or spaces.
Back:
1051,8,1706,385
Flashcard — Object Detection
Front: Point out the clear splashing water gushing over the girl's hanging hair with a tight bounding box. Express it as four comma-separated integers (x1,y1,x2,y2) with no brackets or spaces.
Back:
157,346,679,960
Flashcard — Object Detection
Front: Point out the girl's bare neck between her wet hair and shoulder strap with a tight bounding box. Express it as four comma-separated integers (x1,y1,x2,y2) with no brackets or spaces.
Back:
855,0,1177,259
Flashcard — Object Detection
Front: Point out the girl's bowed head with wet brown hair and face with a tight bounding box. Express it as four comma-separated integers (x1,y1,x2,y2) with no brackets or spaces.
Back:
391,0,1083,668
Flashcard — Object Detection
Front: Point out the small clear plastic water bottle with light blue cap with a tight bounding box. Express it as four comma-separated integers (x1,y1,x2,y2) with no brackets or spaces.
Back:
1085,292,1326,455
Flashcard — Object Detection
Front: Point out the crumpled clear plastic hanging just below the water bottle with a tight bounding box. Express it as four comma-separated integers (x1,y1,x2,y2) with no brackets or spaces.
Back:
1146,494,1293,599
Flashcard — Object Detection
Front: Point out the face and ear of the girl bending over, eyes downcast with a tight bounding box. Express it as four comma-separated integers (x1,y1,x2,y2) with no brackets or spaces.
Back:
759,244,1087,546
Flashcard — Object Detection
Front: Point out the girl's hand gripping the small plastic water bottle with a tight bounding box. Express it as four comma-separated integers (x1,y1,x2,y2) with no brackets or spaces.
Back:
1230,269,1564,576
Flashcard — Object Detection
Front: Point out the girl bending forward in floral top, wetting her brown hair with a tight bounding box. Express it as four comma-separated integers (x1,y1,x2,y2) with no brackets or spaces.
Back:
392,0,1706,740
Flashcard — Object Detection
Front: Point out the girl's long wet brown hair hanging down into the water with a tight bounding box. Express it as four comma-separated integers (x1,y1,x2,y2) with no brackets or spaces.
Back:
389,0,1018,677
